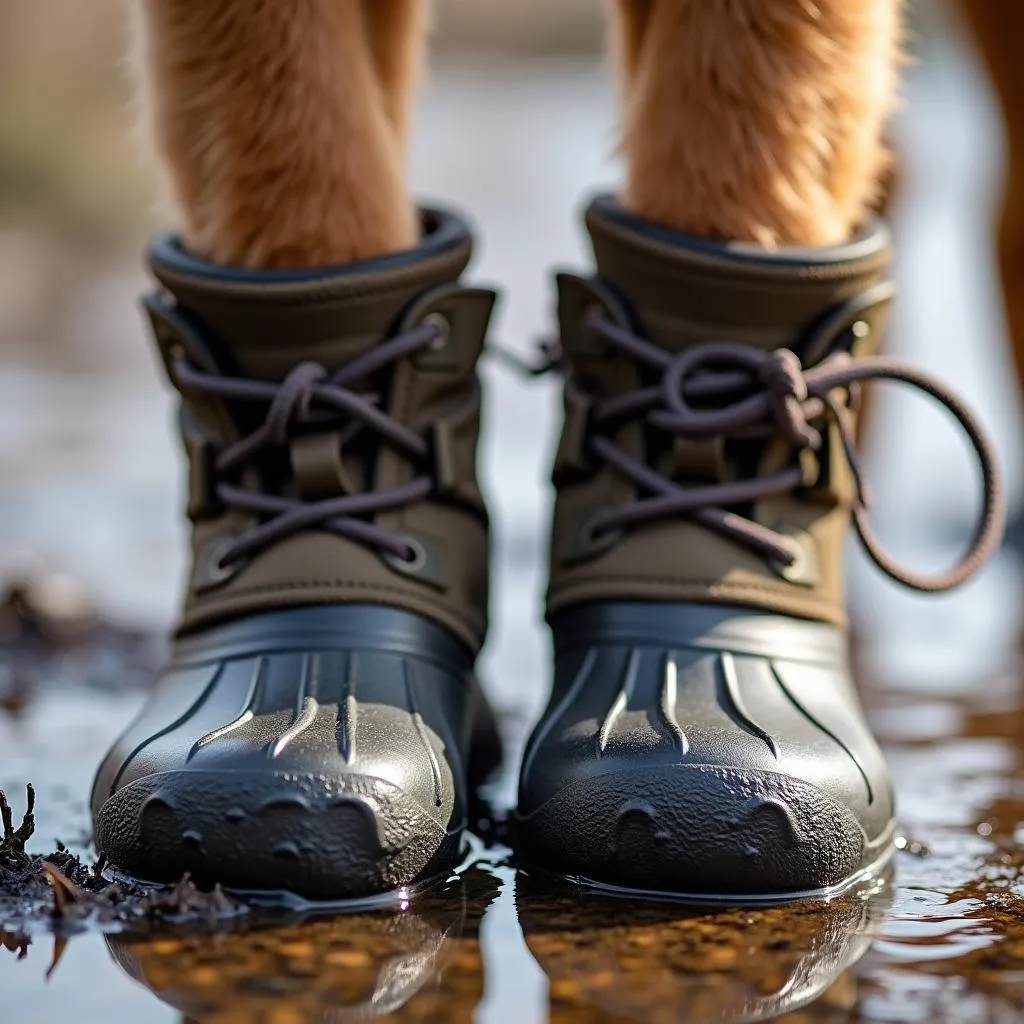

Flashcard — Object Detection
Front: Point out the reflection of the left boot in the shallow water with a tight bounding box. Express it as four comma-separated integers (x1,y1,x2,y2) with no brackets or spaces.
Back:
106,868,498,1024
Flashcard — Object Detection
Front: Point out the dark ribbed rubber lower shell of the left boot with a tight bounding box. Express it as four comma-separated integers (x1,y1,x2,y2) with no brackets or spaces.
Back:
93,605,500,899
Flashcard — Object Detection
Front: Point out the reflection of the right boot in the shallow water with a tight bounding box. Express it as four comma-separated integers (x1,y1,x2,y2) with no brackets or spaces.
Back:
516,871,892,1024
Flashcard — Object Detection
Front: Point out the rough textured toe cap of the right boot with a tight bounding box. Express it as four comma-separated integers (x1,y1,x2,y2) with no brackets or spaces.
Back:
520,764,866,894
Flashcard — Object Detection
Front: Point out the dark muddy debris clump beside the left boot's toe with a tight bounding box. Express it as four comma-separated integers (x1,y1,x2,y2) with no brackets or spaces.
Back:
0,785,248,937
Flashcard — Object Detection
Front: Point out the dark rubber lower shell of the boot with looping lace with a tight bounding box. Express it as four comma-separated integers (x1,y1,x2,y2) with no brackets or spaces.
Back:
516,603,893,896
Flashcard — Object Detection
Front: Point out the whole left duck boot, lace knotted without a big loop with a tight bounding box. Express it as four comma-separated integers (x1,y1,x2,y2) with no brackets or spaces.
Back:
92,211,500,898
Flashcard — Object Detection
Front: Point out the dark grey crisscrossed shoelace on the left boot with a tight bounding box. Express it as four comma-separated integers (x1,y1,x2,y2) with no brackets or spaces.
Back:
173,324,440,566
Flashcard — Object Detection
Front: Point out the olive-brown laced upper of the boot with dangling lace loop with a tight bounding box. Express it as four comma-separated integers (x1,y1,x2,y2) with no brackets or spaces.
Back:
548,194,893,624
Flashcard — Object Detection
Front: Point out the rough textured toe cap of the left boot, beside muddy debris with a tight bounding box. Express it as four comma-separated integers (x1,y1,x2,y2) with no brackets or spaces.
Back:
95,770,458,899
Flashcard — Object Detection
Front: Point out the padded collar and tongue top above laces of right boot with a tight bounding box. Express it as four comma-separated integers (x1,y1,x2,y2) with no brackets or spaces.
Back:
586,197,891,352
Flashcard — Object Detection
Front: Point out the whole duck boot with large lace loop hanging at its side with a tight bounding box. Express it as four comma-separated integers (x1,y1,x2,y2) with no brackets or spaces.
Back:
516,199,1001,900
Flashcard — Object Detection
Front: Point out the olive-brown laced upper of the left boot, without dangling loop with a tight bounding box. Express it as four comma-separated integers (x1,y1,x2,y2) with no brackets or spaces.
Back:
146,214,495,650
